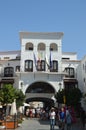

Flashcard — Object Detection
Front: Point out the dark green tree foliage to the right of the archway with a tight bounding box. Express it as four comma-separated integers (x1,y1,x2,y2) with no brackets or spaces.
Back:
55,88,82,107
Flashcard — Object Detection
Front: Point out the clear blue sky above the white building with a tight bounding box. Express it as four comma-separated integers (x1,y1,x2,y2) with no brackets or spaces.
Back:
0,0,86,59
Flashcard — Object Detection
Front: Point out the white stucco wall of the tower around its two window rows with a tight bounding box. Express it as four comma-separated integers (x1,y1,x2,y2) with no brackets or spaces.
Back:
21,39,62,72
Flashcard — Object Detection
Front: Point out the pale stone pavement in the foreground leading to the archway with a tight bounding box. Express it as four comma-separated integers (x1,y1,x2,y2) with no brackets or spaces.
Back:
16,118,83,130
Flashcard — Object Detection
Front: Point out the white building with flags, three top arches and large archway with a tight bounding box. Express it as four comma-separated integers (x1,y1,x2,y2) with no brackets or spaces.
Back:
0,32,86,108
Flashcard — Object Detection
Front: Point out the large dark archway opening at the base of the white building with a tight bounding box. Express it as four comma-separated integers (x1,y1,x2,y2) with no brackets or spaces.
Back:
26,82,55,108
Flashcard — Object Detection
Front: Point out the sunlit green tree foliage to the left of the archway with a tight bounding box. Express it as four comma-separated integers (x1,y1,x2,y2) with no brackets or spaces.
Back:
0,84,25,107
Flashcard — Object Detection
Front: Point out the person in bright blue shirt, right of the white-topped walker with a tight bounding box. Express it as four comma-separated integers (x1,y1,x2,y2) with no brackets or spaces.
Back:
58,107,65,130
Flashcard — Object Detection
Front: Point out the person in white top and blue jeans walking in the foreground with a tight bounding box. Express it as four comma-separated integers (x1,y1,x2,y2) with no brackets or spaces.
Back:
49,108,56,130
